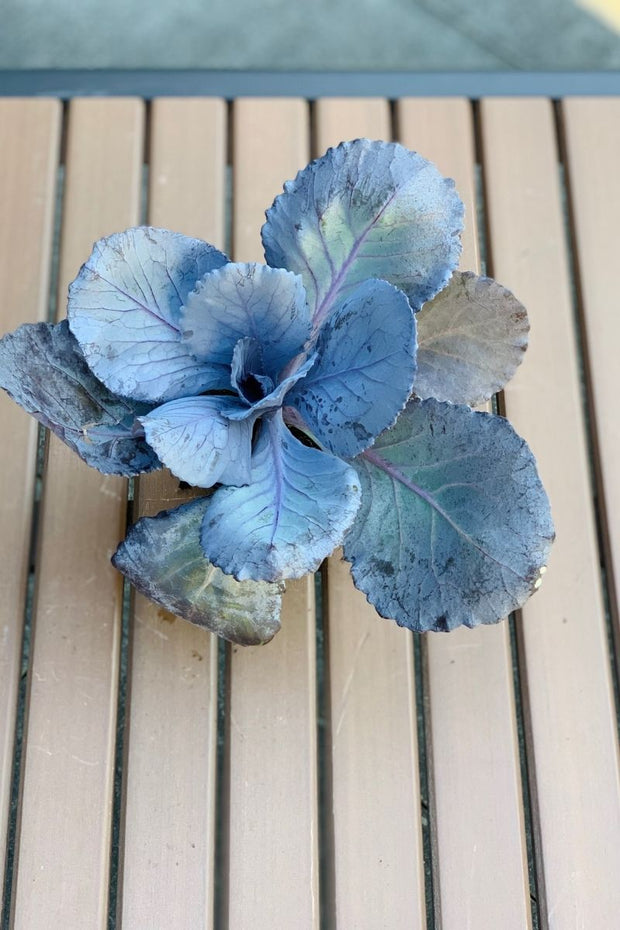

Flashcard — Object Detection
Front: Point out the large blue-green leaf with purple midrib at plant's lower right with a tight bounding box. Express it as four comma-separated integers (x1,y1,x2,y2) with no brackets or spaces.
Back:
344,399,554,631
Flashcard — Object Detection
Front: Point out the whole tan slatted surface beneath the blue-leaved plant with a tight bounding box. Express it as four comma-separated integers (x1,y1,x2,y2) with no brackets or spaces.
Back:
0,89,620,930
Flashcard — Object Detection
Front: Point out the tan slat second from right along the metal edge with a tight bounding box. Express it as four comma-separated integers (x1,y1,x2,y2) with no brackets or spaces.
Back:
481,99,620,928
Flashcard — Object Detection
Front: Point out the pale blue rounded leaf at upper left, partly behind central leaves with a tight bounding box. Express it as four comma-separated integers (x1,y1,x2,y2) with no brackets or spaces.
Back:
67,226,228,403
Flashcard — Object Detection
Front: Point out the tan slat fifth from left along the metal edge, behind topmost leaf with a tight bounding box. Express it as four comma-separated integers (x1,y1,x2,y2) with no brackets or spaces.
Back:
314,99,426,930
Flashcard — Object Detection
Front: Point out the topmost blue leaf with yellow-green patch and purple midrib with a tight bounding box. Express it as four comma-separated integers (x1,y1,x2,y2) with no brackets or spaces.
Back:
262,139,463,327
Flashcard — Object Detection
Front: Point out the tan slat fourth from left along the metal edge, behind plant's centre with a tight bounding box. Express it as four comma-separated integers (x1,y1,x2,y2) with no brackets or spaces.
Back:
228,99,319,930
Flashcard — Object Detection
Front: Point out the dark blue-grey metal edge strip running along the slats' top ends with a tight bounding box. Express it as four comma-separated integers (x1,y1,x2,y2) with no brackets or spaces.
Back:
0,69,620,100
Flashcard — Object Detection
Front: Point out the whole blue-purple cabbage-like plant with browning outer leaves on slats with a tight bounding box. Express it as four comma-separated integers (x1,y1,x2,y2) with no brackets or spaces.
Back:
0,139,553,643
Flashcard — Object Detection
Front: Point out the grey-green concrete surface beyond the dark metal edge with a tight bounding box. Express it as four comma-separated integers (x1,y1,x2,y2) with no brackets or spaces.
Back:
0,0,620,71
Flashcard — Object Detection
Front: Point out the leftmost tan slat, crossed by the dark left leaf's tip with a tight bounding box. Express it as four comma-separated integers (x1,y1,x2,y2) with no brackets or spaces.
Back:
0,99,61,875
